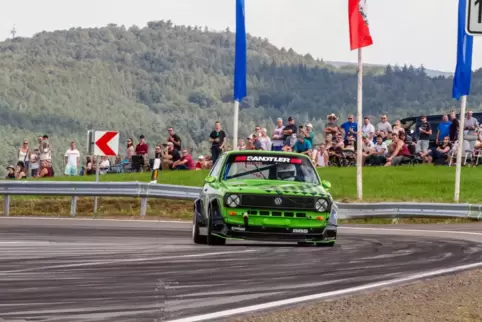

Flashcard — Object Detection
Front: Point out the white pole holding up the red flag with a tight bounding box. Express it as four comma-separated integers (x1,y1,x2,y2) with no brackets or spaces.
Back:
356,48,363,200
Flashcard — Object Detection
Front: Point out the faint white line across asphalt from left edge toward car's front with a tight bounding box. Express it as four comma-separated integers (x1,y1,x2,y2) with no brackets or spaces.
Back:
0,249,257,274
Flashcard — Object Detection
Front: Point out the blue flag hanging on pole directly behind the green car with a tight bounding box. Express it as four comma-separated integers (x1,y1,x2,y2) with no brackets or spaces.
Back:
234,0,247,102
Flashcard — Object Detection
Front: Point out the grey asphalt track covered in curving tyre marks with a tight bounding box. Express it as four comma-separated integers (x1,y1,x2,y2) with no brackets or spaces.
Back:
0,218,482,322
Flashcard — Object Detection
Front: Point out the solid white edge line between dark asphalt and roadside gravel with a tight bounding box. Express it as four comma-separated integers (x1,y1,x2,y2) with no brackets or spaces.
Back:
167,262,482,322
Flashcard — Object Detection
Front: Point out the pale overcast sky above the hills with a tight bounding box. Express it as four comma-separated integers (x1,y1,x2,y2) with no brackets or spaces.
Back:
0,0,482,72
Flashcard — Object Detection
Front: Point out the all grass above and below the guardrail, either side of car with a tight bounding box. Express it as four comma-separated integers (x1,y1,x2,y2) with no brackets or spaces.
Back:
4,165,482,224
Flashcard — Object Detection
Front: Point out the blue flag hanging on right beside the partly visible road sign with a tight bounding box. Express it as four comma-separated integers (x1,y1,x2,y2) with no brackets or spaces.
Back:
452,0,474,100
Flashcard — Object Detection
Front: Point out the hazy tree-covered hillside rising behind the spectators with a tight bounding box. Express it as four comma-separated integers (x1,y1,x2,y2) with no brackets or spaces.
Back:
0,21,482,172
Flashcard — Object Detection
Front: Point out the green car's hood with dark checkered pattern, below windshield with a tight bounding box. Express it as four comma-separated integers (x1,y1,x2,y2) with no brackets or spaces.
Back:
222,180,328,197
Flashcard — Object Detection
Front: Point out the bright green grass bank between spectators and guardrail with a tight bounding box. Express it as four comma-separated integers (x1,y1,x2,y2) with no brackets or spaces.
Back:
40,165,482,203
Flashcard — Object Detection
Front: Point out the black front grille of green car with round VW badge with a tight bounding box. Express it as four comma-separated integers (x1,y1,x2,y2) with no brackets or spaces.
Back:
240,195,315,210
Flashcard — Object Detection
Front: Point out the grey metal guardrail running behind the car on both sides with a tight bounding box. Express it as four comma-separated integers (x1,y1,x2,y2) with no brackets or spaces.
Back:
0,180,482,219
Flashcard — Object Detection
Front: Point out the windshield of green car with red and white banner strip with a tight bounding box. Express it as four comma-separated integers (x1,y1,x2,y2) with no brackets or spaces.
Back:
223,154,320,184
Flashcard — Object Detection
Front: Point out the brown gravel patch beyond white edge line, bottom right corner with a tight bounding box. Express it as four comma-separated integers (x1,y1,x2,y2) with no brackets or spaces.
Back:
231,270,482,322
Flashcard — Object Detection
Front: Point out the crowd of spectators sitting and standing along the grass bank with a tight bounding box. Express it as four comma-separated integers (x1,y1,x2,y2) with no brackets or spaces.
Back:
7,111,482,179
